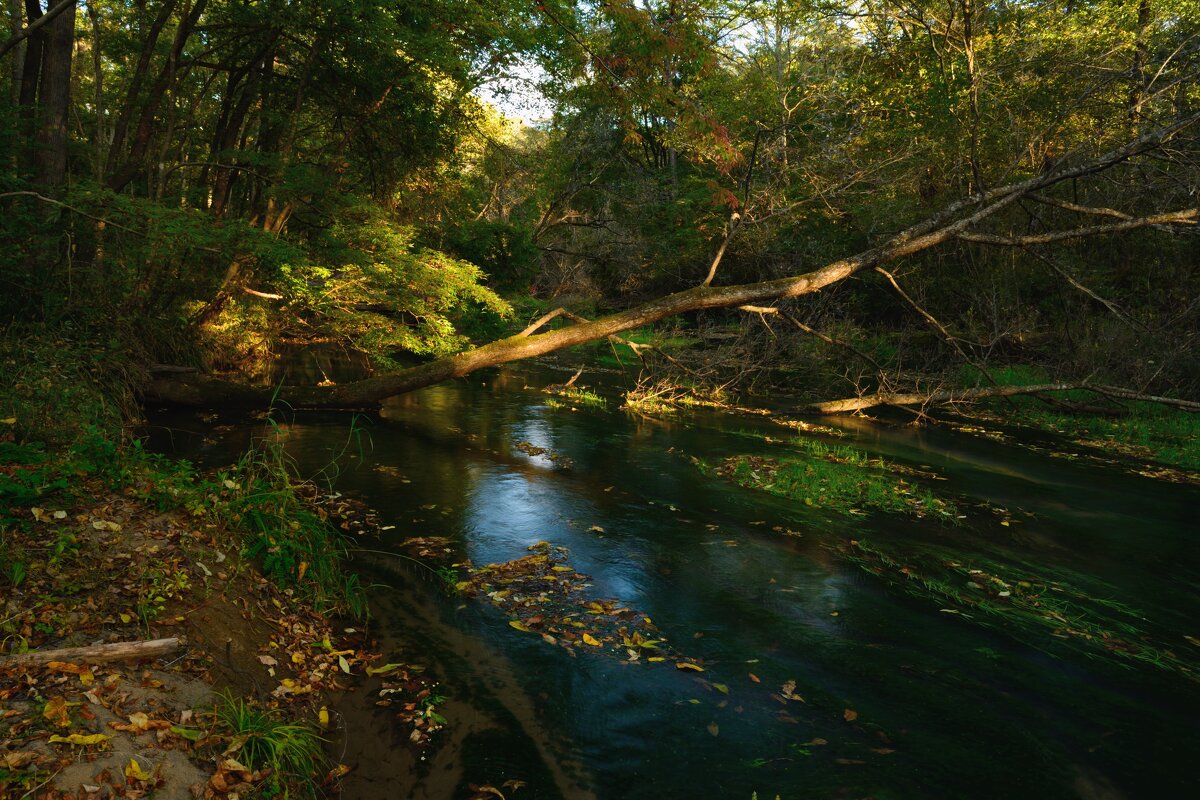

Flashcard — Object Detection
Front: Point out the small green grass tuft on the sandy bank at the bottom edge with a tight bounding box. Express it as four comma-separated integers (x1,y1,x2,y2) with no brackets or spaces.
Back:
215,694,325,798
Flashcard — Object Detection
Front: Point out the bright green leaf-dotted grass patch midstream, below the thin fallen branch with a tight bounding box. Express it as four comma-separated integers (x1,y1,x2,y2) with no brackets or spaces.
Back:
701,438,958,522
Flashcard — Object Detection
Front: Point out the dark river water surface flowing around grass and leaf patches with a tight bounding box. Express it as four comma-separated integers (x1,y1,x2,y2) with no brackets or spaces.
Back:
151,357,1200,800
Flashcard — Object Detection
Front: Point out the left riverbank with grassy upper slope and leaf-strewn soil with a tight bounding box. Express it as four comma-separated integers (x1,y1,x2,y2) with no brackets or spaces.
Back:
0,341,439,799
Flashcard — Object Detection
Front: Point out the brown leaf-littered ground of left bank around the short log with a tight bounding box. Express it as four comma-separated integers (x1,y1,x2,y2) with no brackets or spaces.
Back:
0,450,437,800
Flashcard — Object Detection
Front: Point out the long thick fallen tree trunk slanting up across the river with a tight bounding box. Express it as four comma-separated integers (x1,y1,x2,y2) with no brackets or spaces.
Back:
143,114,1200,409
